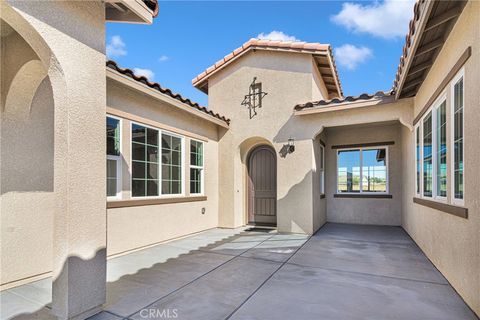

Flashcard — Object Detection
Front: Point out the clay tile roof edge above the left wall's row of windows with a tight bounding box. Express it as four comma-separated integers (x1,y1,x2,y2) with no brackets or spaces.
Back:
107,60,230,124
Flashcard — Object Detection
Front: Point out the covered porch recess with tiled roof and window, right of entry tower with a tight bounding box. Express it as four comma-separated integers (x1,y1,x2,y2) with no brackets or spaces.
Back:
294,92,413,226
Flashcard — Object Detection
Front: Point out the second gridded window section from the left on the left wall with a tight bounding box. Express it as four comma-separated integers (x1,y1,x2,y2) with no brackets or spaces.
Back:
132,123,159,197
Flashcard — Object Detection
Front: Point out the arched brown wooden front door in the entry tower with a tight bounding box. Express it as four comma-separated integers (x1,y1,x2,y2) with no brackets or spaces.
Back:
248,145,277,226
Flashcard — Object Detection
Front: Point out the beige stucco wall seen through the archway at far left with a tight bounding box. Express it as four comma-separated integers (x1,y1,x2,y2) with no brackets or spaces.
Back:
0,28,55,288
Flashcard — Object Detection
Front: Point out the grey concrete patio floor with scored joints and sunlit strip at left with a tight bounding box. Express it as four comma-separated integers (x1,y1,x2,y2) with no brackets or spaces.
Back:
1,223,477,320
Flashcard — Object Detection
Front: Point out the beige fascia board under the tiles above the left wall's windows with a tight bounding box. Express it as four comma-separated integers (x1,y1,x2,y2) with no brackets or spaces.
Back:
107,67,229,129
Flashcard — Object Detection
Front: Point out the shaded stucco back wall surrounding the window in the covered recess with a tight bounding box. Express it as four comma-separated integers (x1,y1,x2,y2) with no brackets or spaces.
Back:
326,122,402,226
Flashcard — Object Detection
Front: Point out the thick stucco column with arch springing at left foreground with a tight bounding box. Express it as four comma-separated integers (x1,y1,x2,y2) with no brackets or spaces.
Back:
3,1,106,319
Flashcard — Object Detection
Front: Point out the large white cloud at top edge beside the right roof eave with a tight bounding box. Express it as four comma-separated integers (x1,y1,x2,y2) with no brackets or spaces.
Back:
331,0,415,39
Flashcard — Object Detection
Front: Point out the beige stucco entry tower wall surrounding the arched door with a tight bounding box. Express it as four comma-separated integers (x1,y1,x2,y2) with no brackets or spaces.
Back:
209,50,330,233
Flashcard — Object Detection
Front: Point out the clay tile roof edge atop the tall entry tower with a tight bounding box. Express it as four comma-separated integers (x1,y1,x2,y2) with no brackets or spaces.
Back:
192,38,343,96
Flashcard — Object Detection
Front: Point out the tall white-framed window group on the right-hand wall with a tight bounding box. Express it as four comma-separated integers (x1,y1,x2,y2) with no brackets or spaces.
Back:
415,70,464,204
